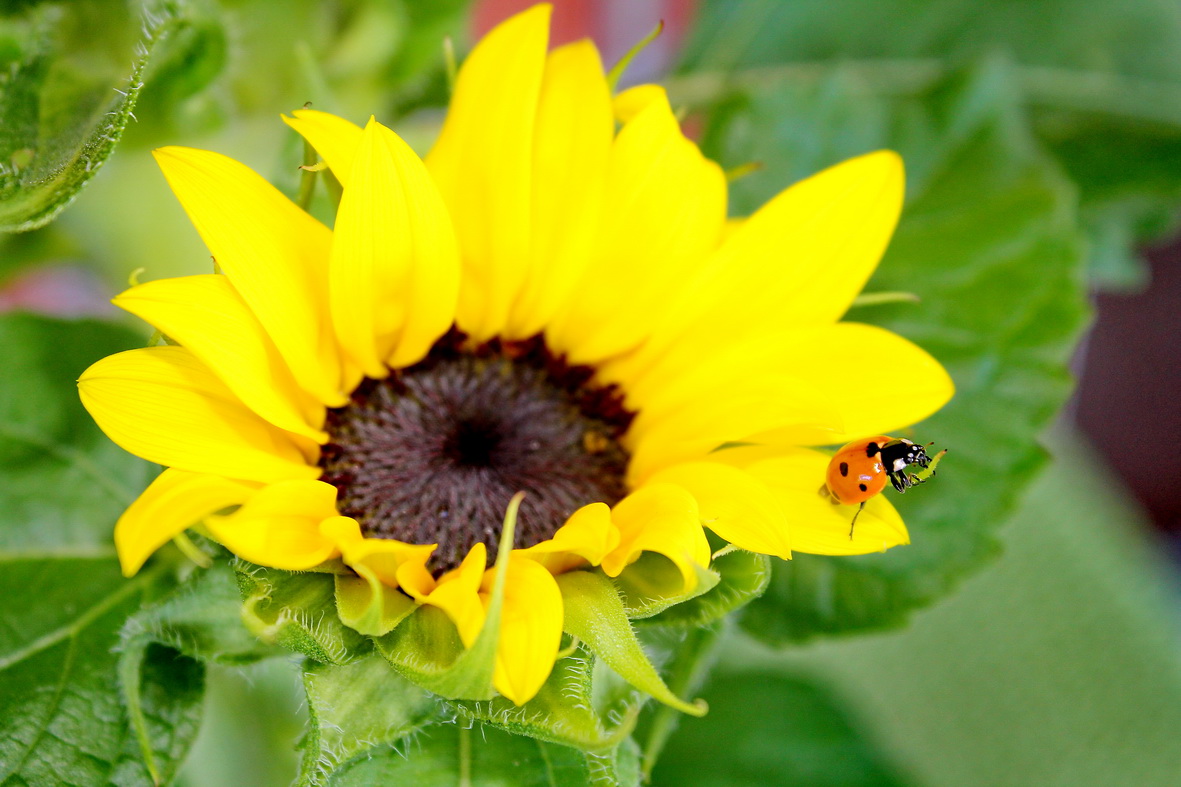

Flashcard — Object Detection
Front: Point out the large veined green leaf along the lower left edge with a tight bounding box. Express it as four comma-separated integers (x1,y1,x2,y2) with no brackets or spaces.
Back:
0,314,204,785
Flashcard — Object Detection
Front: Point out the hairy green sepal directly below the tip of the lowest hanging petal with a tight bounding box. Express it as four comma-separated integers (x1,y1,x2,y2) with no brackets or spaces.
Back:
449,649,639,753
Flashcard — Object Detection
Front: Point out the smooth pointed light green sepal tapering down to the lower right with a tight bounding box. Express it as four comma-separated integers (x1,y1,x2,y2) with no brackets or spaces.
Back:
556,571,706,716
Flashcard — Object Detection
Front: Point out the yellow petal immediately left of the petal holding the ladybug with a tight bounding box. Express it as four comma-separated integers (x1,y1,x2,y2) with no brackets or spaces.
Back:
651,462,793,560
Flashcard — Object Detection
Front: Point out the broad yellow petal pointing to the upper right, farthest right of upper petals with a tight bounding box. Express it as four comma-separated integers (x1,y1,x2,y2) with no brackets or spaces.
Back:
648,150,905,352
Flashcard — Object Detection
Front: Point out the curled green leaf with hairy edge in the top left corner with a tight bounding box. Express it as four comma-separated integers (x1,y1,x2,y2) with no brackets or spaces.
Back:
0,0,193,232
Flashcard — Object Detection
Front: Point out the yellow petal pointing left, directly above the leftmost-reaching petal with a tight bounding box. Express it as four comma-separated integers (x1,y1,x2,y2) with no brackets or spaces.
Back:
113,274,327,443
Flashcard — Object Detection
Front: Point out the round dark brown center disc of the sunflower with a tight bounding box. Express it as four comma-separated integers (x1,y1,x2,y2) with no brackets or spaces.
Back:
320,330,633,570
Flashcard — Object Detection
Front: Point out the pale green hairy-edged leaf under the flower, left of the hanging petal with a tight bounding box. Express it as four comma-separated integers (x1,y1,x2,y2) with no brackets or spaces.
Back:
299,655,441,785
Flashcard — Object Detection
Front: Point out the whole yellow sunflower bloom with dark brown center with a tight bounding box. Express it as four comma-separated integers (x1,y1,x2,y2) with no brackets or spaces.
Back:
79,5,952,704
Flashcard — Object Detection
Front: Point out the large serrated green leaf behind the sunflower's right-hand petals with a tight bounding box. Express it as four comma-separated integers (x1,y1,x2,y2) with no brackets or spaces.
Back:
689,63,1087,644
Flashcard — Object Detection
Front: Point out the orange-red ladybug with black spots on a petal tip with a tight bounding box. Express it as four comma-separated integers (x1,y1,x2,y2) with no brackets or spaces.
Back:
820,435,947,539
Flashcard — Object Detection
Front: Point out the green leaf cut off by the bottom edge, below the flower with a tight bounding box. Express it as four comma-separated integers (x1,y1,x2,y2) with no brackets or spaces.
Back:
329,724,618,787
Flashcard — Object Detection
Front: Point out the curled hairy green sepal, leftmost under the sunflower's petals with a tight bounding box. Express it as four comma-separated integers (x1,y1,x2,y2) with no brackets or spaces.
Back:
234,560,368,664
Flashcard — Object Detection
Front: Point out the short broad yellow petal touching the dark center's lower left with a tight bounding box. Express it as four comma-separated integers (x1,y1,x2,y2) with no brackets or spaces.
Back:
205,481,340,571
